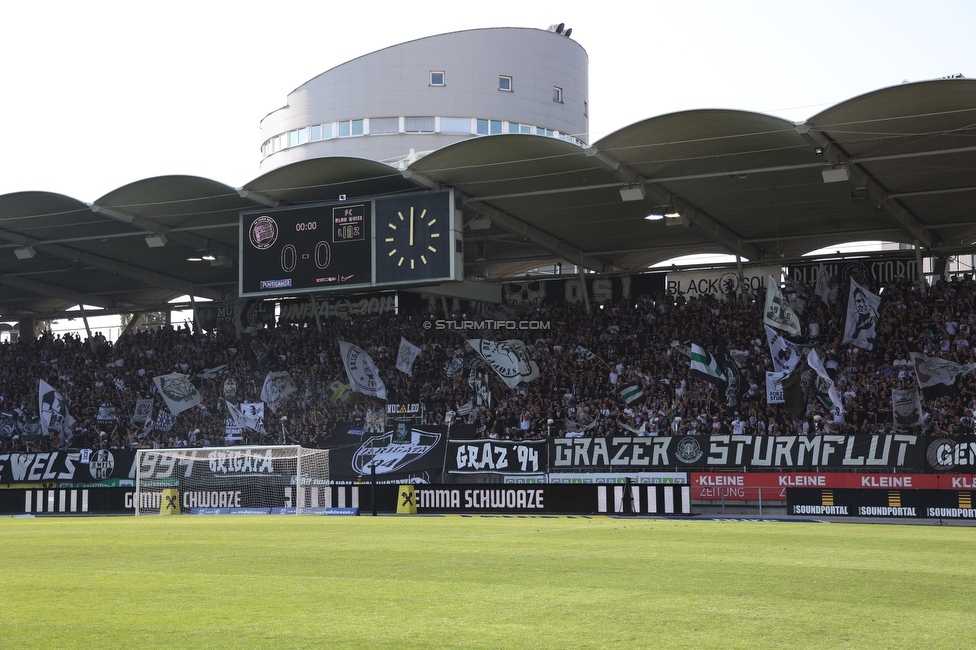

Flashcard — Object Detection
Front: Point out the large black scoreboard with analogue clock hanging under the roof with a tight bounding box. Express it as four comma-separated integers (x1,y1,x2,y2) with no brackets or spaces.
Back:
239,190,464,297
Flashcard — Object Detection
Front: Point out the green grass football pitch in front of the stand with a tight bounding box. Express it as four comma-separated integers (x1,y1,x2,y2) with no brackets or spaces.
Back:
0,516,976,650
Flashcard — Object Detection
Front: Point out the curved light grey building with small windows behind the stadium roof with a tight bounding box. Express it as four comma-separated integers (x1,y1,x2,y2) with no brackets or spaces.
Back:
261,27,589,172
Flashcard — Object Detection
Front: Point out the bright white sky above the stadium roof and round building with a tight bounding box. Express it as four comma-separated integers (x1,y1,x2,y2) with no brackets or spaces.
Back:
0,0,976,202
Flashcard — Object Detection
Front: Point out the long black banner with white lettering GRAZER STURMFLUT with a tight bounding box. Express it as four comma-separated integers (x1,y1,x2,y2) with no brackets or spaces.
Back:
549,433,928,472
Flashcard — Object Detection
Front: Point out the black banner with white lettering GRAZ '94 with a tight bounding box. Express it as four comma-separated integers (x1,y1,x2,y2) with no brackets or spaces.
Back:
447,440,546,474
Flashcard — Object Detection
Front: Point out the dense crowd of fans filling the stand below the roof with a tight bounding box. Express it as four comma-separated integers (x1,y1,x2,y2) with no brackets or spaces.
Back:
0,275,976,451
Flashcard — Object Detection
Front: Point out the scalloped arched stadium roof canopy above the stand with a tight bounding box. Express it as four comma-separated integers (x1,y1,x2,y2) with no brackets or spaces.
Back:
0,79,976,320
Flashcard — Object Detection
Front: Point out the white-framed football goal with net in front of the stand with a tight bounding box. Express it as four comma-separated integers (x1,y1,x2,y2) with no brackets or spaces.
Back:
134,445,329,515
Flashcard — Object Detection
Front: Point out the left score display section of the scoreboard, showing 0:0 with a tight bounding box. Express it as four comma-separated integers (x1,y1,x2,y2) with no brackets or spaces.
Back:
240,201,373,296
